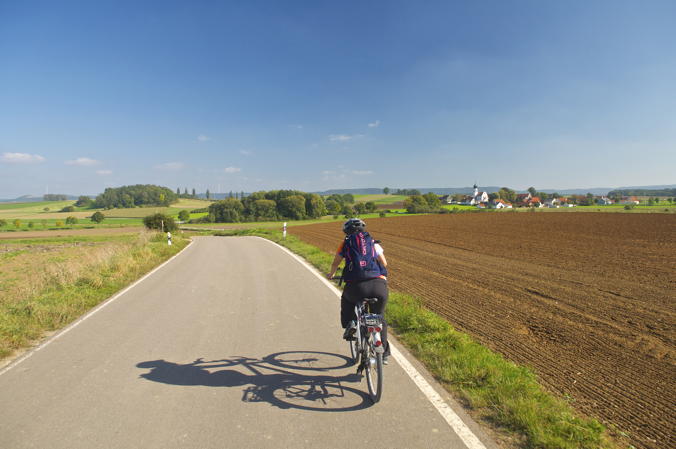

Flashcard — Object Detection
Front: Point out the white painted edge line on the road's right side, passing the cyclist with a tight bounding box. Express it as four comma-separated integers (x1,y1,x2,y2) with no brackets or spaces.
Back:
258,237,486,449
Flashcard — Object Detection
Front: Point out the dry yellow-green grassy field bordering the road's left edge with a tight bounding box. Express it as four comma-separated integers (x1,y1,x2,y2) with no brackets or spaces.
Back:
0,232,188,359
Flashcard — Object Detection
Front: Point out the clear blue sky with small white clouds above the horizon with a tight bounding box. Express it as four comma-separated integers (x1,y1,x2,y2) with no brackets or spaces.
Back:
0,0,676,198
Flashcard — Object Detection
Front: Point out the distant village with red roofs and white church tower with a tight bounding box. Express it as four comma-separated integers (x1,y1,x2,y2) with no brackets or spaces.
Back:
440,184,640,209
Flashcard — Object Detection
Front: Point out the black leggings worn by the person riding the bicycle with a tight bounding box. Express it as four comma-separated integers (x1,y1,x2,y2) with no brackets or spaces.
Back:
340,278,390,354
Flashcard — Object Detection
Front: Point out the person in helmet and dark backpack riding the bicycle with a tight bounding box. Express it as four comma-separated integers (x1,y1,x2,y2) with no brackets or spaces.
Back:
327,218,390,362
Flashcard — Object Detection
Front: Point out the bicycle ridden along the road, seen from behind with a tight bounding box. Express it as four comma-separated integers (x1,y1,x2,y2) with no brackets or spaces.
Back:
348,298,385,403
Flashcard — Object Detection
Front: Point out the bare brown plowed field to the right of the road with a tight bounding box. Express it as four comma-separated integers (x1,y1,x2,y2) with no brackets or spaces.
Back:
289,213,676,449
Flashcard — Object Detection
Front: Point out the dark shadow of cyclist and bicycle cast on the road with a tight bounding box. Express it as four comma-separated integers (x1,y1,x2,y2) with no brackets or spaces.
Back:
136,351,372,412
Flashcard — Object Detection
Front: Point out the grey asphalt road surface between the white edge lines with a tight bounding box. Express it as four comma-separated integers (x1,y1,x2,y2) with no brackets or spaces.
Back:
0,237,493,449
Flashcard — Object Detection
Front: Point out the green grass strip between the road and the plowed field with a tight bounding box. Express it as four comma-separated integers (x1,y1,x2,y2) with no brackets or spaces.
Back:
214,229,614,449
